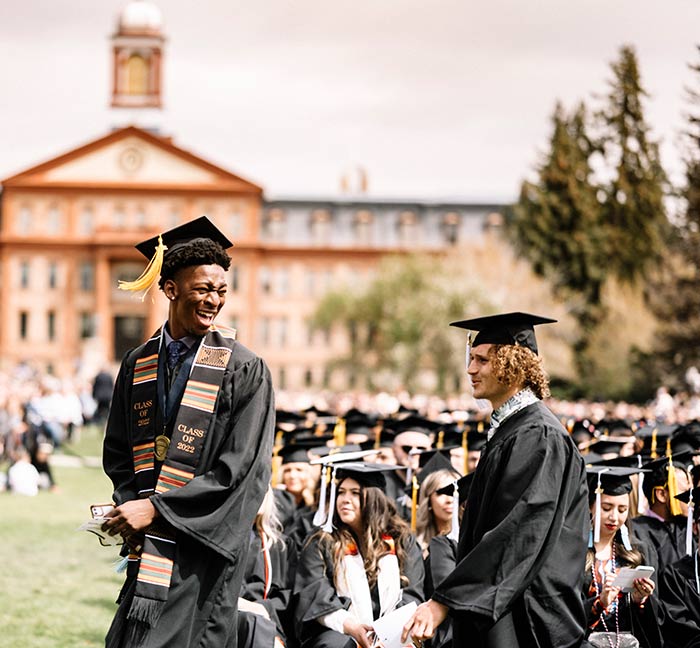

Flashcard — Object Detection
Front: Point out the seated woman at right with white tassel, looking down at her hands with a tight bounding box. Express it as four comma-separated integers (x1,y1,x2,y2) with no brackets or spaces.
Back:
584,466,663,648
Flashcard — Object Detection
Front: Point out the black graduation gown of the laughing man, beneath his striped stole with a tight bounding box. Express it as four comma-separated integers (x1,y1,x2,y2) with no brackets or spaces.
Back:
103,343,275,648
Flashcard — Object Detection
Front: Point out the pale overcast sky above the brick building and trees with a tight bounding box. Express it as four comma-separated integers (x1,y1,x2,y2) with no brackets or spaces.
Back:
0,0,700,200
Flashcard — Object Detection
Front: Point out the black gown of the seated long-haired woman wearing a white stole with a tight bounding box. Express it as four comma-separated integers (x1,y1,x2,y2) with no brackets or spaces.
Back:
293,536,424,648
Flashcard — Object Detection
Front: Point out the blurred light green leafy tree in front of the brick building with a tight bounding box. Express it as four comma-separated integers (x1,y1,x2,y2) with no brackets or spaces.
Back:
314,256,493,392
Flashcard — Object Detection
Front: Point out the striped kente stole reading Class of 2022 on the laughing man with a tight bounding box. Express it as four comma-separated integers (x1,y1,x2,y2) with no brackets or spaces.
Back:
128,325,236,646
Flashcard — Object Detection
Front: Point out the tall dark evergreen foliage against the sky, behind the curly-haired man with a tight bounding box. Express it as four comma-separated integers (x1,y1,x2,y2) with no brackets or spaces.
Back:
509,46,669,394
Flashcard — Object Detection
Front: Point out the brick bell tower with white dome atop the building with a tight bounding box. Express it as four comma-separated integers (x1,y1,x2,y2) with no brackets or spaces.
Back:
111,0,165,108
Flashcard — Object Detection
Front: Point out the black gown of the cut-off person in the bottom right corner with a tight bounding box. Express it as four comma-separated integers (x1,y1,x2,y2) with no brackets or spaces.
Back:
659,555,700,648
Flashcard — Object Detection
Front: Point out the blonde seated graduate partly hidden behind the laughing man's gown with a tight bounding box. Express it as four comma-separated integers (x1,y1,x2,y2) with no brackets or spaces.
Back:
238,487,297,648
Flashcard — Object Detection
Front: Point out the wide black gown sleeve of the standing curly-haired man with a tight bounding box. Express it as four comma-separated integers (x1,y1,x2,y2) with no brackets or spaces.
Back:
433,424,583,625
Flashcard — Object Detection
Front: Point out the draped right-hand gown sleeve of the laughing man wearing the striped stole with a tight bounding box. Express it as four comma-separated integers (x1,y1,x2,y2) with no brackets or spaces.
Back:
151,351,275,561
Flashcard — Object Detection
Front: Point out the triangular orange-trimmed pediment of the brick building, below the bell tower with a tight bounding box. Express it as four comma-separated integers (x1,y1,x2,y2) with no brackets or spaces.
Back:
2,126,262,194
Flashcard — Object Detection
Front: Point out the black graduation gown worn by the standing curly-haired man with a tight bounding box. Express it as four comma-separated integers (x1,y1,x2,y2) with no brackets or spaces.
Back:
432,402,589,648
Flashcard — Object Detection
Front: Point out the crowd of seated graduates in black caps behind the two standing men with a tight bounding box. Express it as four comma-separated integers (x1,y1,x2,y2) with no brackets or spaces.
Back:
224,398,700,648
